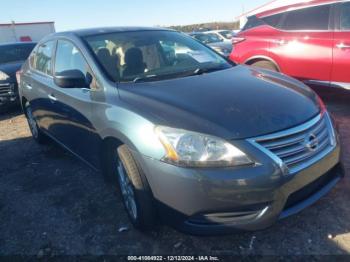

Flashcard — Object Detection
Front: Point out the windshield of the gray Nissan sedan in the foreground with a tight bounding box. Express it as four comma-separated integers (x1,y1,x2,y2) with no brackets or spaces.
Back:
85,31,232,82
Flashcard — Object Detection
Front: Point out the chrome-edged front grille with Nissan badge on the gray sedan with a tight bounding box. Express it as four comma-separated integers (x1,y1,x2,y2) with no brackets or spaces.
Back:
255,114,334,173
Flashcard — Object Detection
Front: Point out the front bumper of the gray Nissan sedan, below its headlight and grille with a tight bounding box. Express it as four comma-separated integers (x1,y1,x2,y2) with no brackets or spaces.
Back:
137,139,344,235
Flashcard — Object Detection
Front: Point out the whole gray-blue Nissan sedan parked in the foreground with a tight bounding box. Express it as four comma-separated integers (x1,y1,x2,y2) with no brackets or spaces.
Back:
20,28,343,234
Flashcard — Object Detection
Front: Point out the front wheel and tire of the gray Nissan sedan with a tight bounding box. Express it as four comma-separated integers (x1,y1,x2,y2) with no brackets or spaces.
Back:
113,145,156,231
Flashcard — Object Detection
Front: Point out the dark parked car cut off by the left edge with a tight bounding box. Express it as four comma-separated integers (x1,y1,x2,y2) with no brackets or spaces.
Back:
0,43,36,106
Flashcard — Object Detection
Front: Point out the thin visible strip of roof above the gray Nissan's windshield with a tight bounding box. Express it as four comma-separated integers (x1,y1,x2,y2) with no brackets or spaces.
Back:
51,26,174,37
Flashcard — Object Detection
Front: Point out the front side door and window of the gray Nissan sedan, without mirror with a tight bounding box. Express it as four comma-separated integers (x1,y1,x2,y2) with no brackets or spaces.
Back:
50,40,99,166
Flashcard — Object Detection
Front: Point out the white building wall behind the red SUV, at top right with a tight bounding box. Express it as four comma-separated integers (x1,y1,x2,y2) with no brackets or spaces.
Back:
236,0,310,29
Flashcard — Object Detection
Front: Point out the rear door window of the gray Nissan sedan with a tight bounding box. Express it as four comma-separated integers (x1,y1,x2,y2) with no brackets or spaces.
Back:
34,41,55,75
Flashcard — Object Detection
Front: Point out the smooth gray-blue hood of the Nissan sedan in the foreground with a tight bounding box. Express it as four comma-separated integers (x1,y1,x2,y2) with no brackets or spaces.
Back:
120,66,320,139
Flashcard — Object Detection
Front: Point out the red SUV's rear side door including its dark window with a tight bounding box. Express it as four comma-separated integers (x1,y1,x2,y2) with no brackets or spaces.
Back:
271,5,333,82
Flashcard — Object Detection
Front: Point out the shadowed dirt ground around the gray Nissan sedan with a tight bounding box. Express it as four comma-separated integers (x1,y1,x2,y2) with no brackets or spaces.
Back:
0,89,350,256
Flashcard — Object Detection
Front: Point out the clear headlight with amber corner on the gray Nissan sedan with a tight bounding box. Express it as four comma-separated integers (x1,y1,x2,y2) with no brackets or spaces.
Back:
155,126,253,167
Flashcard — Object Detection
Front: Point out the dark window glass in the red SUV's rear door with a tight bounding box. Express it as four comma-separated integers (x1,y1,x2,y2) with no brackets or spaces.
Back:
282,5,331,30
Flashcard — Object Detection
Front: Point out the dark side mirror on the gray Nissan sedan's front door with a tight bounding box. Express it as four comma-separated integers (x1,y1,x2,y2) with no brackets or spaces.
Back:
54,70,88,88
